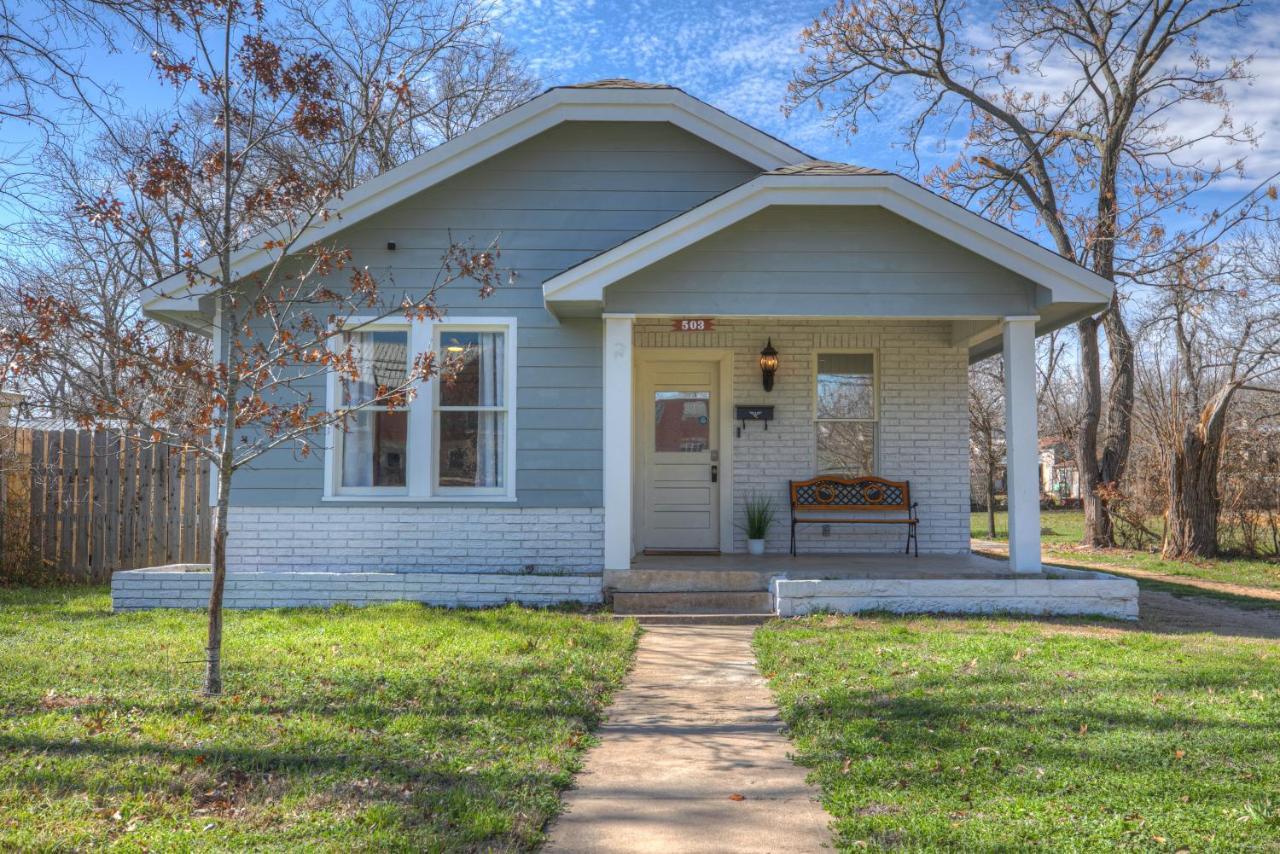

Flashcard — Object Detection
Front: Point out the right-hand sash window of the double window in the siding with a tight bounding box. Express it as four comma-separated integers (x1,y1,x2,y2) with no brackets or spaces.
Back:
431,321,516,495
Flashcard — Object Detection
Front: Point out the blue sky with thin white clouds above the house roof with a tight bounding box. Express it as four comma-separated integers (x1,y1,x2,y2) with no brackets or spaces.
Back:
0,0,1280,222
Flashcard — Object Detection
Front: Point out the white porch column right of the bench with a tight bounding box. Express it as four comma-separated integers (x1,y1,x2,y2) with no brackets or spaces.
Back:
1004,318,1041,572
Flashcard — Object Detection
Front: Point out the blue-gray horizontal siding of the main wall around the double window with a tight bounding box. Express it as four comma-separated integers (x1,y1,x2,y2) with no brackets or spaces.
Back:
233,123,759,507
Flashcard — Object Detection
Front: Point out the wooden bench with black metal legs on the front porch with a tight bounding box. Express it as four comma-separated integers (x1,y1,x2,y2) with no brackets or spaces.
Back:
788,476,920,557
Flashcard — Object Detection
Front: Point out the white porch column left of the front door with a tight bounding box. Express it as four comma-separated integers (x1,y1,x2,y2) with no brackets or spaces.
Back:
604,315,635,570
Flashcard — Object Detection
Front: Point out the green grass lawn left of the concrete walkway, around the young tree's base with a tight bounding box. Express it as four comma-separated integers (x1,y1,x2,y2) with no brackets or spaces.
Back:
0,589,636,851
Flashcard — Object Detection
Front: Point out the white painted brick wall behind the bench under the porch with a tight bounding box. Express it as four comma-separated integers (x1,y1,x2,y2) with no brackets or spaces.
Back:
635,318,969,554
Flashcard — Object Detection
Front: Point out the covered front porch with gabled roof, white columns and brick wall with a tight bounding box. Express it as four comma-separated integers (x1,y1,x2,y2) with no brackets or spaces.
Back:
543,165,1128,613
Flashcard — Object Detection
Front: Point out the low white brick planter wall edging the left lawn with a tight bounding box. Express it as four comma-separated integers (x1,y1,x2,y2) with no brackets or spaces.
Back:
111,567,602,611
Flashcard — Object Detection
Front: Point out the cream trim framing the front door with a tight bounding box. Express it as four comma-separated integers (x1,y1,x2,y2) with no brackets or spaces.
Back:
631,347,735,556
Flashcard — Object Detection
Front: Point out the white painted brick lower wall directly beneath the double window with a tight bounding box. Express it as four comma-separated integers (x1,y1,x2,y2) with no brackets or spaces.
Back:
227,504,604,575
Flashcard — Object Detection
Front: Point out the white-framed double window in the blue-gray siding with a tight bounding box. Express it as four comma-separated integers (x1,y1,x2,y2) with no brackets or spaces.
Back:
325,318,516,502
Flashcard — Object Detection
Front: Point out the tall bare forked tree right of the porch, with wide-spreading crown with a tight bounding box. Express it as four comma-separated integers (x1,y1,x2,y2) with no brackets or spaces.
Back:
788,0,1252,545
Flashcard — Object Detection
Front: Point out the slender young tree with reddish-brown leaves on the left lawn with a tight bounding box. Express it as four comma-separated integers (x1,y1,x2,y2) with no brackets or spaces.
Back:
0,0,502,695
